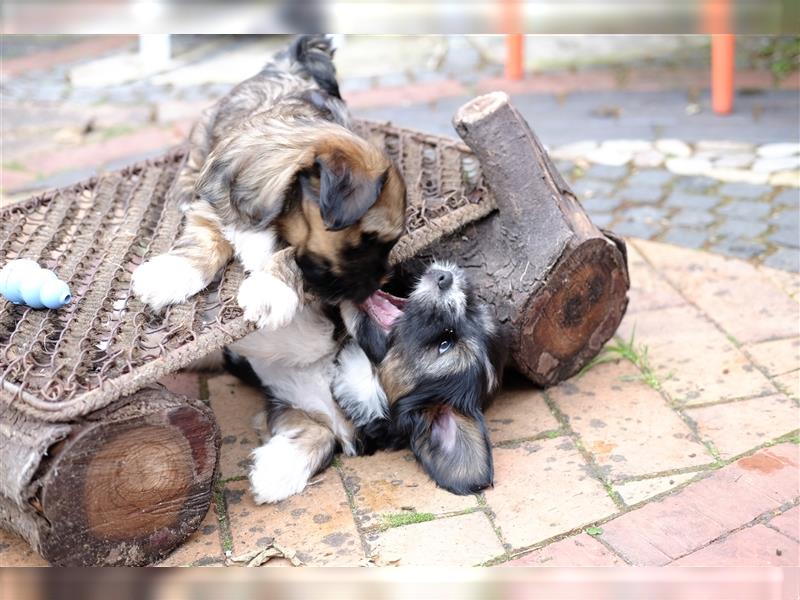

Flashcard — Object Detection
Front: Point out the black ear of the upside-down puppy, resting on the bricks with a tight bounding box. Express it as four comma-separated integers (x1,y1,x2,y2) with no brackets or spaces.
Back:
411,405,494,495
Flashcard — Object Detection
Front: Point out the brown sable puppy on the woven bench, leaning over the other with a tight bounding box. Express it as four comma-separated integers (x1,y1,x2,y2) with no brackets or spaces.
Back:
132,35,405,328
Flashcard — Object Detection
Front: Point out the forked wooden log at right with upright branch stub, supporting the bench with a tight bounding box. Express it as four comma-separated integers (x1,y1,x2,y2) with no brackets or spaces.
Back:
405,92,630,386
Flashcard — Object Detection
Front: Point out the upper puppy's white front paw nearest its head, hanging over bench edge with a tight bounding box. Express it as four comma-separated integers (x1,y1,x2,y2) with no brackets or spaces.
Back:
237,272,300,329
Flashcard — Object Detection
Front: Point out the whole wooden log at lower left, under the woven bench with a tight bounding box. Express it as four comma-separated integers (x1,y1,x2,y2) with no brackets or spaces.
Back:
0,386,219,566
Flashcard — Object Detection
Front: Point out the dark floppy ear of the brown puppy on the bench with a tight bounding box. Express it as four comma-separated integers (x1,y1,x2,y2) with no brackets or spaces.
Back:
301,158,387,231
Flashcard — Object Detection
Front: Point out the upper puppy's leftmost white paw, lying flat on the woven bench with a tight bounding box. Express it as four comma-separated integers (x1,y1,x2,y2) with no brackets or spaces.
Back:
131,254,206,310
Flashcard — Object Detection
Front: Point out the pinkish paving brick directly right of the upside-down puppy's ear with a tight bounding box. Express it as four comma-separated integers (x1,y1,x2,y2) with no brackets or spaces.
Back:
485,377,560,444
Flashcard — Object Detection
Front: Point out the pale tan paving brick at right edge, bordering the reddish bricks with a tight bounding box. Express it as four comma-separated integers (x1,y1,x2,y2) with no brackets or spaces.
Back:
686,395,800,459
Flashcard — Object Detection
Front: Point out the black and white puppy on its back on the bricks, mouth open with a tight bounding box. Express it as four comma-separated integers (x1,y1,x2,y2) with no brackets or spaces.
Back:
226,264,504,503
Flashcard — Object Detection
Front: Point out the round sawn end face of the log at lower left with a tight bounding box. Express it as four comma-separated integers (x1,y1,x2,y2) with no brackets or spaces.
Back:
35,389,219,566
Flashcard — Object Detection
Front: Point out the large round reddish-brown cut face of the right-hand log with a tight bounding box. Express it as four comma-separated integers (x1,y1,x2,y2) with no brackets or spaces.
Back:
513,238,629,386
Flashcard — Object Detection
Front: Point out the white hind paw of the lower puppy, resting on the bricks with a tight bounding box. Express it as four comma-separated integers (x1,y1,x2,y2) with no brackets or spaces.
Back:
250,435,311,504
